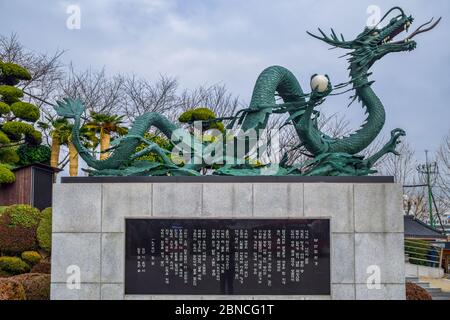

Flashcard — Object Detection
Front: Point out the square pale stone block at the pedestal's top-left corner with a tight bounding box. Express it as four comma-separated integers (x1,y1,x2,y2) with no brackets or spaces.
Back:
52,183,102,232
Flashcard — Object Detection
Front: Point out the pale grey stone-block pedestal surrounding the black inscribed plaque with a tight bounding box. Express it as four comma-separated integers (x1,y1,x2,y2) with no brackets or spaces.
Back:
51,177,405,300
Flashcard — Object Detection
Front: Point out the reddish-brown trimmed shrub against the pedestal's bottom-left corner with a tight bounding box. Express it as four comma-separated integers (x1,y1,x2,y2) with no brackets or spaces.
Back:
9,273,50,300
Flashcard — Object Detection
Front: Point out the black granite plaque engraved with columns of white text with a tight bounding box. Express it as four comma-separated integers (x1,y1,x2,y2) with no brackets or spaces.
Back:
125,219,330,295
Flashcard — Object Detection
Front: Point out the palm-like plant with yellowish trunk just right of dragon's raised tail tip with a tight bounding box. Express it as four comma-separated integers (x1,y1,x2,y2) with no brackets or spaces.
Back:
85,112,128,160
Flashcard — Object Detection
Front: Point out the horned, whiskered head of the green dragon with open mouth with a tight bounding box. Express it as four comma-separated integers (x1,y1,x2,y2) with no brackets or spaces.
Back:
308,7,441,70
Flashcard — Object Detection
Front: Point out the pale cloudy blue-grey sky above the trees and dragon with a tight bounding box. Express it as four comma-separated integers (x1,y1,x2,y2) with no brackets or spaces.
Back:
0,0,450,160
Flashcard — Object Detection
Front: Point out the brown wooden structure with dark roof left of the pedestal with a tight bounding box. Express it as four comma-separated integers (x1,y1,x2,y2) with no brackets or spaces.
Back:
0,163,61,210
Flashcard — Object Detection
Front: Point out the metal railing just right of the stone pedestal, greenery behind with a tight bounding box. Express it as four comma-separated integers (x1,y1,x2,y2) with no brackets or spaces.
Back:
405,239,443,268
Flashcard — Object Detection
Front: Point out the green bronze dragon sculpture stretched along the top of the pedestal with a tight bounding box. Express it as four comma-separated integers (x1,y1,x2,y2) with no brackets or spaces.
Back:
55,7,441,176
